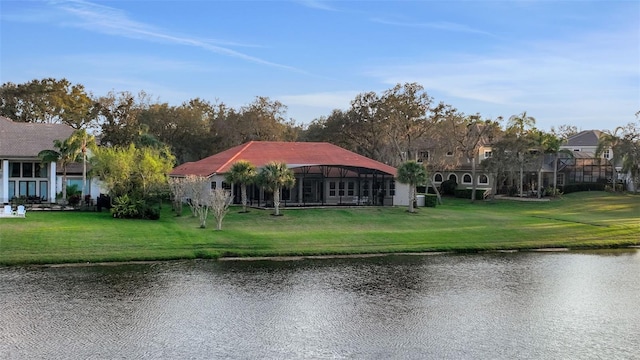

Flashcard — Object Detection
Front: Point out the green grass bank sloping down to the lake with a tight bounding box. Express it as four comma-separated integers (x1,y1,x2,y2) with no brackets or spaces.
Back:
0,192,640,265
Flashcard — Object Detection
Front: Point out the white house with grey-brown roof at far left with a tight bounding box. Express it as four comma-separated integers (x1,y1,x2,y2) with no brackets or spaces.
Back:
0,116,99,204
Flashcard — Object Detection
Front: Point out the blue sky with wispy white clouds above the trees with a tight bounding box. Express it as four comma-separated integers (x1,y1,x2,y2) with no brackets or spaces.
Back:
0,0,640,130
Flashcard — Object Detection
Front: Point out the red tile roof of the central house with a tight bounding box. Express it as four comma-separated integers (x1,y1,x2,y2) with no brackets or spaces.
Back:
171,141,396,176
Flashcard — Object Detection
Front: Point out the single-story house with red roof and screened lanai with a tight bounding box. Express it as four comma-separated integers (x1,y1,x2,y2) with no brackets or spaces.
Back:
170,141,408,206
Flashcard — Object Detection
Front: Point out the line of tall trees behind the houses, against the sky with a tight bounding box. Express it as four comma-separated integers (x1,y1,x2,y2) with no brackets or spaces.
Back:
0,78,640,211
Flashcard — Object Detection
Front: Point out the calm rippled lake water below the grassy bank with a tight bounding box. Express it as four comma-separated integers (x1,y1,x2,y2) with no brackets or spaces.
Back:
0,250,640,359
